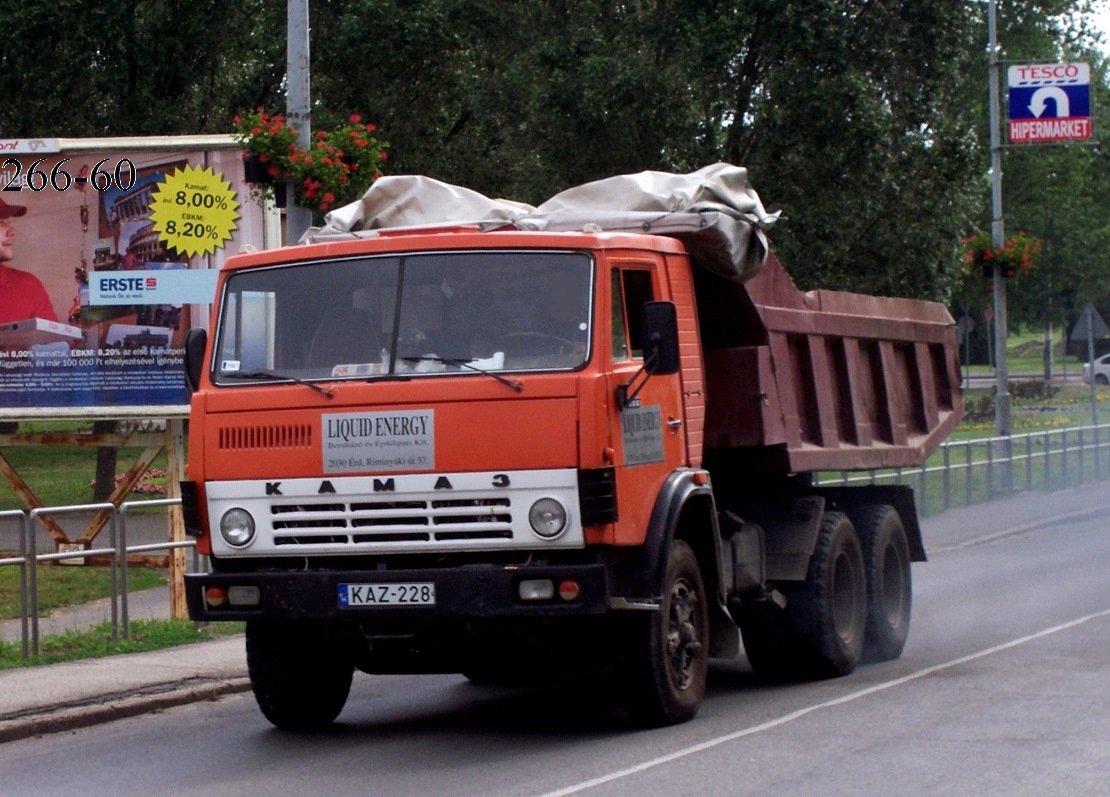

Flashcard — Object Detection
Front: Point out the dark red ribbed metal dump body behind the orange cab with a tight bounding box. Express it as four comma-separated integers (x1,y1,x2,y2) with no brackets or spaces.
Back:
695,254,962,474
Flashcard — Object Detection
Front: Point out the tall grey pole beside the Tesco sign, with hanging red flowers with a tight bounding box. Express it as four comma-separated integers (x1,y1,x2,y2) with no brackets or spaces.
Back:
987,0,1012,493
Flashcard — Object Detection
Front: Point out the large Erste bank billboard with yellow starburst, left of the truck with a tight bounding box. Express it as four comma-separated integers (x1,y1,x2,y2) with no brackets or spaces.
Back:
0,137,265,417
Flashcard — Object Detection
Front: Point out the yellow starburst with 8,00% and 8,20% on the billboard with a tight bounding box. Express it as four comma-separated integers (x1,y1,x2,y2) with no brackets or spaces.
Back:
150,165,239,256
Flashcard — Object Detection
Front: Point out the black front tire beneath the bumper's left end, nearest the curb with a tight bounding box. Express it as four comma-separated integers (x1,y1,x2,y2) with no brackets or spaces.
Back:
246,621,354,730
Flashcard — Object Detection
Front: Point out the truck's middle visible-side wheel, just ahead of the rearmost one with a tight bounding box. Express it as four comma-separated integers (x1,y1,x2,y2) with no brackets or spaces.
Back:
787,512,867,678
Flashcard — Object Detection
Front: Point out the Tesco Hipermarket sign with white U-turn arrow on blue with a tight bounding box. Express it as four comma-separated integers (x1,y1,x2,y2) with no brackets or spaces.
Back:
1006,63,1091,144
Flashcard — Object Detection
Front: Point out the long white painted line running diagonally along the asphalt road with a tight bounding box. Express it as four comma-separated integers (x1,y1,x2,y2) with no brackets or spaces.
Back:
539,609,1110,797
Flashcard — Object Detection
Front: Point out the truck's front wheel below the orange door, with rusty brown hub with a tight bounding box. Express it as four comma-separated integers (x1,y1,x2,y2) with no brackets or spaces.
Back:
620,539,709,726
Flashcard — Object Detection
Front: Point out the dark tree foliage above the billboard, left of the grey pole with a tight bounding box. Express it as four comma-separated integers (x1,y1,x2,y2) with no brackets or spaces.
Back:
0,0,285,138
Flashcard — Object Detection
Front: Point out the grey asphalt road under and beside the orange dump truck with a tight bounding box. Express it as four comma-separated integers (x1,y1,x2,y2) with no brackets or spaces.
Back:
0,486,1110,797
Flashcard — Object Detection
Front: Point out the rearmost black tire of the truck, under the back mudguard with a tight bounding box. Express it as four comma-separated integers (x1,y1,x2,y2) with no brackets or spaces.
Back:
856,504,914,662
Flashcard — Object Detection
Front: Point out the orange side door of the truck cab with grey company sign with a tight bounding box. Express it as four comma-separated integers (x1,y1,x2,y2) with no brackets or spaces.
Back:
609,263,686,544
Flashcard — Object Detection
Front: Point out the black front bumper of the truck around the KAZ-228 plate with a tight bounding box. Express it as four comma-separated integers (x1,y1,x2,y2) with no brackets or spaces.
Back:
185,564,609,622
